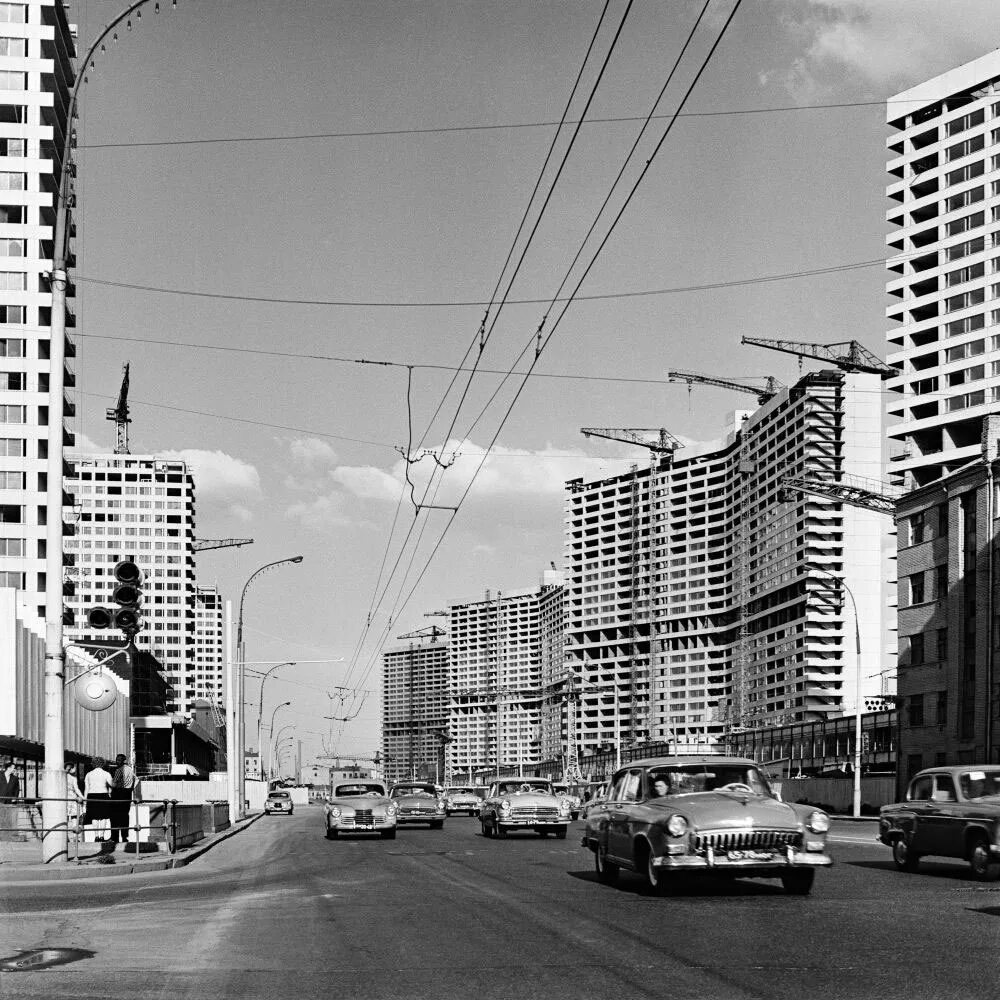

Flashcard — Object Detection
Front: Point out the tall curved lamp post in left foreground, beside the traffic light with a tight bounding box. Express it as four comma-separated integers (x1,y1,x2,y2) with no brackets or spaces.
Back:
42,0,174,864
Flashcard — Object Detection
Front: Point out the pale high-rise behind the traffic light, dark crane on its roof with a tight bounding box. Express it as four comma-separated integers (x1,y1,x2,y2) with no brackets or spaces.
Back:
66,455,198,713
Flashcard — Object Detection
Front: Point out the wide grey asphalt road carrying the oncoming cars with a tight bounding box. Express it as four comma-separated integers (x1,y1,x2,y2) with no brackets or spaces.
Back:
0,807,1000,1000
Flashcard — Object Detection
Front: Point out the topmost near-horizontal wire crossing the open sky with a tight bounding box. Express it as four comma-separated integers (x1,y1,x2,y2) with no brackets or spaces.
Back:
77,100,892,149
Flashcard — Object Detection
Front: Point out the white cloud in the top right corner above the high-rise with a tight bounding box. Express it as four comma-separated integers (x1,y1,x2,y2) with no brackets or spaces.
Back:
761,0,996,102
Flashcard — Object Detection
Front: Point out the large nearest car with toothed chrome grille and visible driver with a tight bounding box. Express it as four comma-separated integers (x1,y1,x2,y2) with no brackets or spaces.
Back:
583,755,833,895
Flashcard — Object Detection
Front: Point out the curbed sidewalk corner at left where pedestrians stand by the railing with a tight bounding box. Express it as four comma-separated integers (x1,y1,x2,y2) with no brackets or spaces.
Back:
0,813,264,884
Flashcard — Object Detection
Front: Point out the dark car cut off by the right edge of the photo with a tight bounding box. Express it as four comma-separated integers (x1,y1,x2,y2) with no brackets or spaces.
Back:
878,764,1000,881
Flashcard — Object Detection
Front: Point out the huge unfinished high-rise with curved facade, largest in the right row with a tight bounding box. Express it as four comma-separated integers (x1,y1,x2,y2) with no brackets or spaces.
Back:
565,371,891,753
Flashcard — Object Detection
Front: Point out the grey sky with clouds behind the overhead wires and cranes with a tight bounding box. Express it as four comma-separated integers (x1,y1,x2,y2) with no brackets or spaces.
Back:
62,0,1000,764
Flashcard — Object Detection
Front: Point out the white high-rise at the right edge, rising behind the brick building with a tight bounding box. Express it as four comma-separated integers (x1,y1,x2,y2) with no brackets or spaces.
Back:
886,50,1000,487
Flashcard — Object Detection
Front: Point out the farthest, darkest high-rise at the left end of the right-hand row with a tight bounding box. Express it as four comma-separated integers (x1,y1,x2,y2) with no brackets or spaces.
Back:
382,629,449,781
